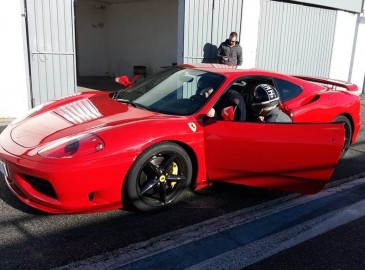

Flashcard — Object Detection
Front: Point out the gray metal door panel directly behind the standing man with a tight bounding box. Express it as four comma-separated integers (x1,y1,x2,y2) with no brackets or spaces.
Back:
183,0,243,63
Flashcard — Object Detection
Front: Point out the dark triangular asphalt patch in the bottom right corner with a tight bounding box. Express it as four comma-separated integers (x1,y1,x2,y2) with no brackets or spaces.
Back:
244,217,365,270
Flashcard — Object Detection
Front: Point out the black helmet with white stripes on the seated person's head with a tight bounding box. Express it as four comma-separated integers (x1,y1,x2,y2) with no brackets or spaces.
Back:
252,84,279,110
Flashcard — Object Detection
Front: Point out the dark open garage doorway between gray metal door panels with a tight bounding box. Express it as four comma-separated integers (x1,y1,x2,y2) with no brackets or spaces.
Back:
75,0,178,91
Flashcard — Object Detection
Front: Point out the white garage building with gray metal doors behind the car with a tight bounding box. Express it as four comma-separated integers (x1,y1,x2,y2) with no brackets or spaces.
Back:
0,0,365,118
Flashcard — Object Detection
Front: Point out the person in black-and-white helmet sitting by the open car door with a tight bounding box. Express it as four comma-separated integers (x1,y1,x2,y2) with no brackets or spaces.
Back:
251,84,292,123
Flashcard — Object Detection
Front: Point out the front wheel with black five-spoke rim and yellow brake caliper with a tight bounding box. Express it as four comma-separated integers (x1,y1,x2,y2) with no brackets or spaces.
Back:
124,142,192,211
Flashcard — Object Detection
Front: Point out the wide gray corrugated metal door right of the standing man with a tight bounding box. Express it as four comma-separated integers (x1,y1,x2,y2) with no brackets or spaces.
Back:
256,0,336,77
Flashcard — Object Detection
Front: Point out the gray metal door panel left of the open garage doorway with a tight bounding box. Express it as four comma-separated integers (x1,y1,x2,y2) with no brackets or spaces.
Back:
26,0,76,105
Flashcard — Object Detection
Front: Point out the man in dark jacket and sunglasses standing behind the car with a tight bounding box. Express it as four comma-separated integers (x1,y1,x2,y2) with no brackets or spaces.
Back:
218,32,242,66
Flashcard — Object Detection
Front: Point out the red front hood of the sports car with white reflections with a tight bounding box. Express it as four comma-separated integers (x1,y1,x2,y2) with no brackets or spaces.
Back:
10,94,167,148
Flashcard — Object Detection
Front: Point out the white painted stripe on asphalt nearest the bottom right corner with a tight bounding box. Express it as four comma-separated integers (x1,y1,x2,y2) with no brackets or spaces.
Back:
187,200,365,270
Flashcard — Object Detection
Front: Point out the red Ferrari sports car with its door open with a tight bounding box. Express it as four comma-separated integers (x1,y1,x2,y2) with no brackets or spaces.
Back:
0,64,360,213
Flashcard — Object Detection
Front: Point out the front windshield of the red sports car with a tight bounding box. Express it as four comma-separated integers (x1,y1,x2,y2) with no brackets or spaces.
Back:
114,67,224,115
